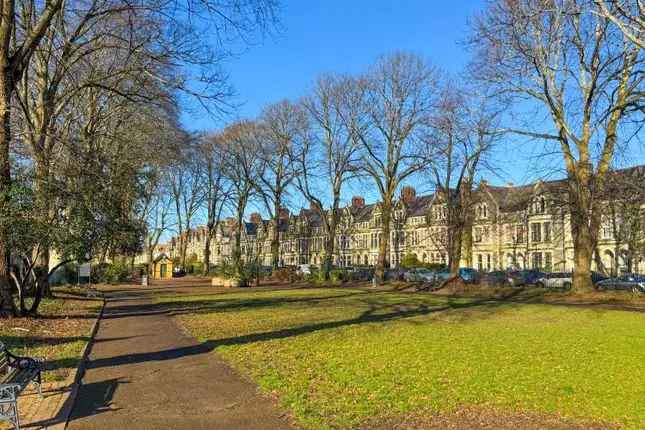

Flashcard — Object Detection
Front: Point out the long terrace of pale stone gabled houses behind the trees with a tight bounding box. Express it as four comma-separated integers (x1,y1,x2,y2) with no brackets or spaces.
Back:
150,166,645,273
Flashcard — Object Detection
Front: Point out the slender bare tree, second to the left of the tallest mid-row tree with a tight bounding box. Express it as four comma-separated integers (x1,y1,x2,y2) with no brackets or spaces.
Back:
257,100,307,269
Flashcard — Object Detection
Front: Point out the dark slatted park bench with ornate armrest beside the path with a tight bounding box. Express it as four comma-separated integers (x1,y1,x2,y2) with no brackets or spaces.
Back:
0,342,45,430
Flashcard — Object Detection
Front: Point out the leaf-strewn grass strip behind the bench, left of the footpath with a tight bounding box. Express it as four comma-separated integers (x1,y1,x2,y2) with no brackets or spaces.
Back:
0,290,101,382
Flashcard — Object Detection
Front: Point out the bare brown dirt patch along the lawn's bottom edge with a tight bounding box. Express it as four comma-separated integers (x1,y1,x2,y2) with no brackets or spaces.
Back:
359,408,620,430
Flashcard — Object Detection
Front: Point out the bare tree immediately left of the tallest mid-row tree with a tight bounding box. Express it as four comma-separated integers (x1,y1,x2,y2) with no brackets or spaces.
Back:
294,75,364,279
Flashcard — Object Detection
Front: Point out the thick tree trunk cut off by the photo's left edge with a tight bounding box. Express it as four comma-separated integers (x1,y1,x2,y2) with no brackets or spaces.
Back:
0,73,16,316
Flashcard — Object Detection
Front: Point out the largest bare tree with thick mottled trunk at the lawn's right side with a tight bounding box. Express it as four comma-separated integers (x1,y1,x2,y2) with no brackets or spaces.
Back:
471,0,645,290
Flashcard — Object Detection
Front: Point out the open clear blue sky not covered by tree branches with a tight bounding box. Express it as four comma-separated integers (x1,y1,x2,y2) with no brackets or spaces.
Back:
177,0,645,203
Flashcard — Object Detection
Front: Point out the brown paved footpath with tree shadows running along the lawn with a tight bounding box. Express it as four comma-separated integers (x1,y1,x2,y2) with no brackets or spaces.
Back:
67,287,291,430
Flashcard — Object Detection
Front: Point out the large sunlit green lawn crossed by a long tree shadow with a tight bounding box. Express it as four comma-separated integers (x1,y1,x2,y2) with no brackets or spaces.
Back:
159,288,645,429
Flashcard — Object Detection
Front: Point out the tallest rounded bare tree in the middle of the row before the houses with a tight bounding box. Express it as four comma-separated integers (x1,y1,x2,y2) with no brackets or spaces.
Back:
352,53,436,282
